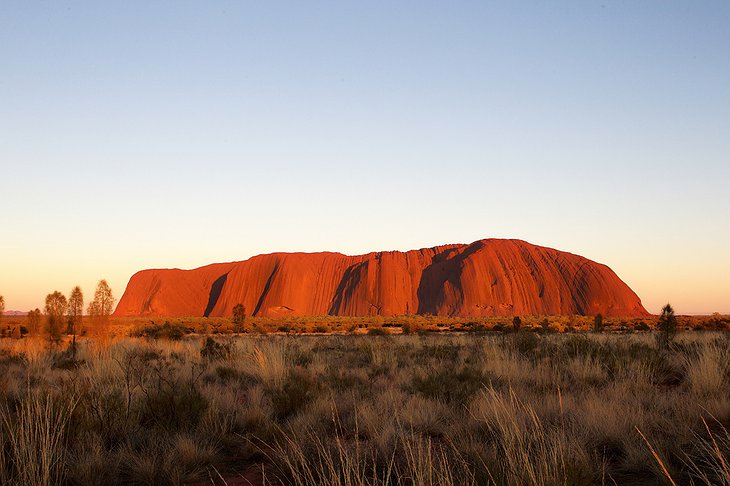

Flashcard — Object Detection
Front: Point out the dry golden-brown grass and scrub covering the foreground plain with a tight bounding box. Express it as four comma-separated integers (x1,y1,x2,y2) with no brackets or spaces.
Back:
0,332,730,485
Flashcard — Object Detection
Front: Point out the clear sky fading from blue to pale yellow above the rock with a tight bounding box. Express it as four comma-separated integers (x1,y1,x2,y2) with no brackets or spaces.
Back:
0,0,730,313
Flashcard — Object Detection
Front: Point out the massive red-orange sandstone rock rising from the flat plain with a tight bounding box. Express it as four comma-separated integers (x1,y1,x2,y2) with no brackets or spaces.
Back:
114,239,648,317
